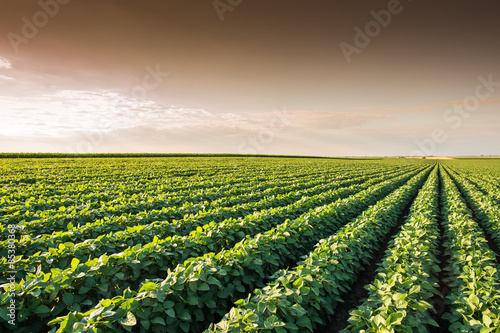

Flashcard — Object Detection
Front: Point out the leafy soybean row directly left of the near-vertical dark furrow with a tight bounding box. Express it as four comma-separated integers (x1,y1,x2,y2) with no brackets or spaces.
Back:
345,168,442,333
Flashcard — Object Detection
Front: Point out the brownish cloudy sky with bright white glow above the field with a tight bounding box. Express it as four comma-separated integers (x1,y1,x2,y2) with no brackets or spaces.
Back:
0,0,500,156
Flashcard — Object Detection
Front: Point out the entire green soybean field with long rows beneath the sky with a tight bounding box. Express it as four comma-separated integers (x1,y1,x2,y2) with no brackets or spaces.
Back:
0,156,500,333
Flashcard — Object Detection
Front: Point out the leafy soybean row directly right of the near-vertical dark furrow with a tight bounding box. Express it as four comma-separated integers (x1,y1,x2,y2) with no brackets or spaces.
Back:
441,167,500,333
